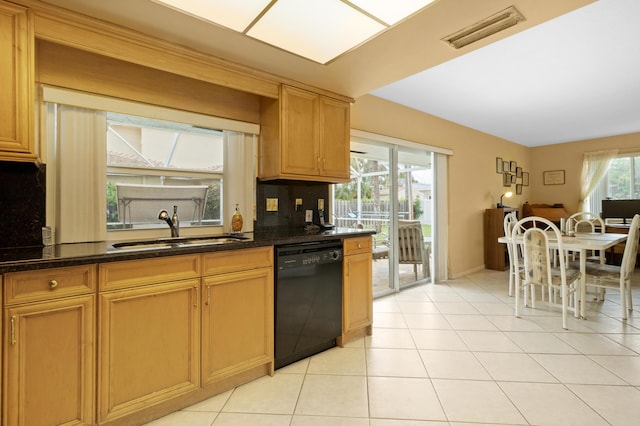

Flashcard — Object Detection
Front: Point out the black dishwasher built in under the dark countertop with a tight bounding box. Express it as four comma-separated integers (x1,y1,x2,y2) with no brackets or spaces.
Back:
275,241,342,368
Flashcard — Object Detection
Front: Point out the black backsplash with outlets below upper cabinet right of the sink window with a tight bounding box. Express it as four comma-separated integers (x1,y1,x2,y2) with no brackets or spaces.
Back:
254,180,331,232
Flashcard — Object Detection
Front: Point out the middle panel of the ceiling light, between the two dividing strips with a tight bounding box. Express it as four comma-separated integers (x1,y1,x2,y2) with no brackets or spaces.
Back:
247,0,386,64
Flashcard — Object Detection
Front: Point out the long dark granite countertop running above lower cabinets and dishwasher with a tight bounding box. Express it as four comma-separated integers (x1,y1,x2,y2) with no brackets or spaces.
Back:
0,228,374,273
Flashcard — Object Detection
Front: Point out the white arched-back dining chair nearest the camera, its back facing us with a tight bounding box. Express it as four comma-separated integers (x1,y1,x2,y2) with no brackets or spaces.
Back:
511,216,580,329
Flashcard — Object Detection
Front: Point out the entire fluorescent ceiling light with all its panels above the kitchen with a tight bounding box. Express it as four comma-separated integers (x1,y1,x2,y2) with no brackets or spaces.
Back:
153,0,434,64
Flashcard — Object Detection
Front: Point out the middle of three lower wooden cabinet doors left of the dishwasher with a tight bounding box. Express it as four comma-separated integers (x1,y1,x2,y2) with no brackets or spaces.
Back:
98,279,200,423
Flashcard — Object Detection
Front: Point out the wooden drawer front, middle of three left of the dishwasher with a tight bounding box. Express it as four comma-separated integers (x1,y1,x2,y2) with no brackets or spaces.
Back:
99,255,200,291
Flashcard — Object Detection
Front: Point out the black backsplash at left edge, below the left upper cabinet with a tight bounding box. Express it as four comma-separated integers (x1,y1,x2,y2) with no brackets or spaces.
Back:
0,161,46,248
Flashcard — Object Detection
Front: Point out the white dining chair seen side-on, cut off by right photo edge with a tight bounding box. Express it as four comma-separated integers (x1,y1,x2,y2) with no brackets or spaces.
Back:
585,214,640,320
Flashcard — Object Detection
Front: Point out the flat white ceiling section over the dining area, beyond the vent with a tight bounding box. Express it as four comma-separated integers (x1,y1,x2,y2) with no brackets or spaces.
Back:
372,0,640,146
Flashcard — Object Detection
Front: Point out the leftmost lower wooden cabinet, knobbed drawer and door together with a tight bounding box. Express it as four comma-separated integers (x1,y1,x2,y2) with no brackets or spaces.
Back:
2,265,96,426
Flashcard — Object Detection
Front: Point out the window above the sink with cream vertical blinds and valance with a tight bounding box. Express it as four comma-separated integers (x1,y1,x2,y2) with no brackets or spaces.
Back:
45,86,259,243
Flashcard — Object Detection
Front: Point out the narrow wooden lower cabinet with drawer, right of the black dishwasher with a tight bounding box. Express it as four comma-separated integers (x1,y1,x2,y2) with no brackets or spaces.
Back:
338,236,373,345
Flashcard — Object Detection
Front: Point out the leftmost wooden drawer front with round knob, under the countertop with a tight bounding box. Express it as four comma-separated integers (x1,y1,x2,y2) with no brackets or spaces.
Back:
4,265,97,305
